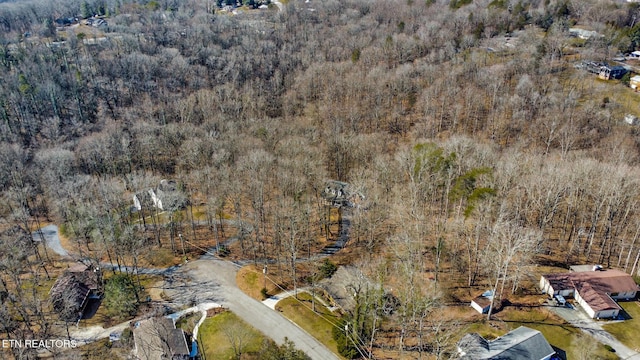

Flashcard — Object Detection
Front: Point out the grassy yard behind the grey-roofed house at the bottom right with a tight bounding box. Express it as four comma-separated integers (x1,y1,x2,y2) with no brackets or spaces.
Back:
466,308,618,360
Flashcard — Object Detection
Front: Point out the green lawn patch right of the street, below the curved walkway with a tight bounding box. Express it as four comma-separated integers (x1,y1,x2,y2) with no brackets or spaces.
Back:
276,292,339,354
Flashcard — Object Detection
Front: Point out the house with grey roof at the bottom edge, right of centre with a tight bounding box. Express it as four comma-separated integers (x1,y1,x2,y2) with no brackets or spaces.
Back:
458,326,555,360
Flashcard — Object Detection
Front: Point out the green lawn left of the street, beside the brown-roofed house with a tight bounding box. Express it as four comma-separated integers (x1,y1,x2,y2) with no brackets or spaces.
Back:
198,311,266,360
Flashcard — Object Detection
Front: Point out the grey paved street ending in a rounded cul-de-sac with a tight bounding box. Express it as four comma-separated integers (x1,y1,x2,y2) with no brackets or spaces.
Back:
164,258,339,360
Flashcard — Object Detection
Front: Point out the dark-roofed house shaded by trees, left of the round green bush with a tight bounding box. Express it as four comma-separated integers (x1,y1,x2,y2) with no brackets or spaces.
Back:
49,263,100,322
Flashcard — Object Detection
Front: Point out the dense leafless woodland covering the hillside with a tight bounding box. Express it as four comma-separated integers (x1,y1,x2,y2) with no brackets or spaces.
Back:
0,0,640,357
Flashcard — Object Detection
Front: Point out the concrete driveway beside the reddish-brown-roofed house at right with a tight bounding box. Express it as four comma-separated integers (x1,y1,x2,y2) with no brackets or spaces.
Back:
549,306,640,360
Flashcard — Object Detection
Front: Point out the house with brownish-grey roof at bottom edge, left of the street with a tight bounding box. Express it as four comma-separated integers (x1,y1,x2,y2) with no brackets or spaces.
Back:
133,317,190,360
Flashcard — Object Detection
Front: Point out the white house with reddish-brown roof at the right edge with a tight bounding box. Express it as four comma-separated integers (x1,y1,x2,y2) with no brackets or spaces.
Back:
540,267,638,319
